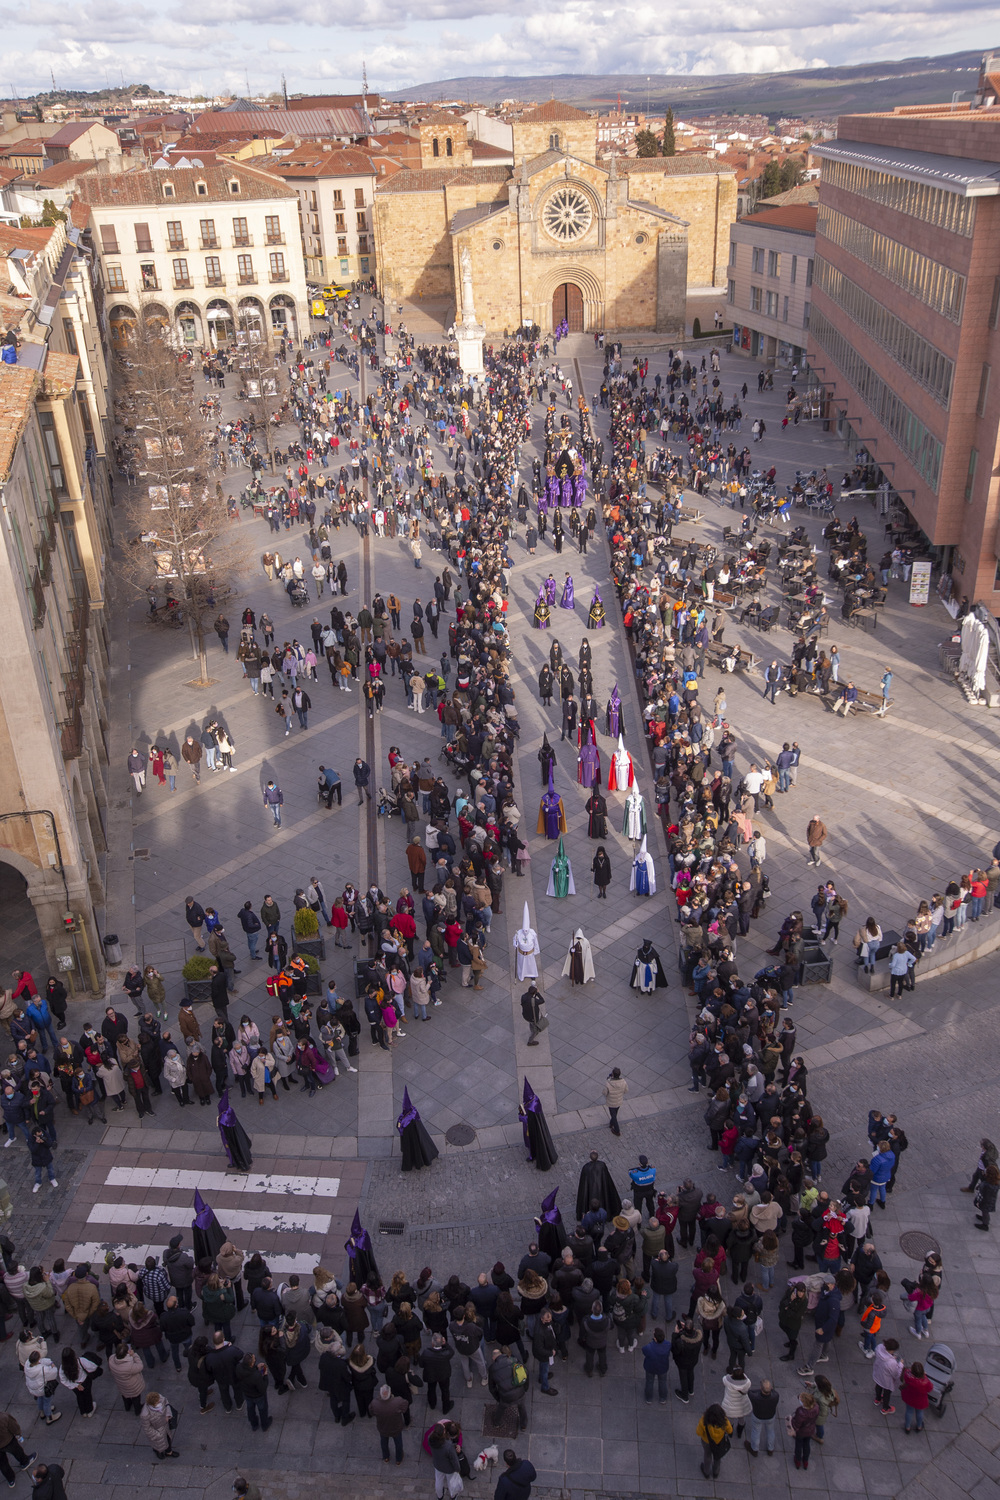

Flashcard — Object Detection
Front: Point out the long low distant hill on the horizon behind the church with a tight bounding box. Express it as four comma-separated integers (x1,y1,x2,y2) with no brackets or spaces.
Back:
382,51,982,119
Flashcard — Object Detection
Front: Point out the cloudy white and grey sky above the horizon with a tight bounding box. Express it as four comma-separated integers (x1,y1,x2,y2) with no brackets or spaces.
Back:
0,0,997,98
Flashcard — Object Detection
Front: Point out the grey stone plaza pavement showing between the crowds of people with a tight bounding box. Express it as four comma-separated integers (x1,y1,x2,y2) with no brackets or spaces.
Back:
0,319,1000,1500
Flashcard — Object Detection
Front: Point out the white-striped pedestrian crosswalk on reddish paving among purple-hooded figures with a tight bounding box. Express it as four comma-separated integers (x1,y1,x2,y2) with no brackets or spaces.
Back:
52,1151,364,1275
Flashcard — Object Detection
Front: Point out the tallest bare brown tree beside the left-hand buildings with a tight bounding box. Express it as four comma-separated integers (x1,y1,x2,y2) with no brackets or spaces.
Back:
115,315,237,686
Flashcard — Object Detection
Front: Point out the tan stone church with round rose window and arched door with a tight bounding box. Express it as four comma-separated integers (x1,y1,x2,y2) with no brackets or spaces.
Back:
373,101,736,338
